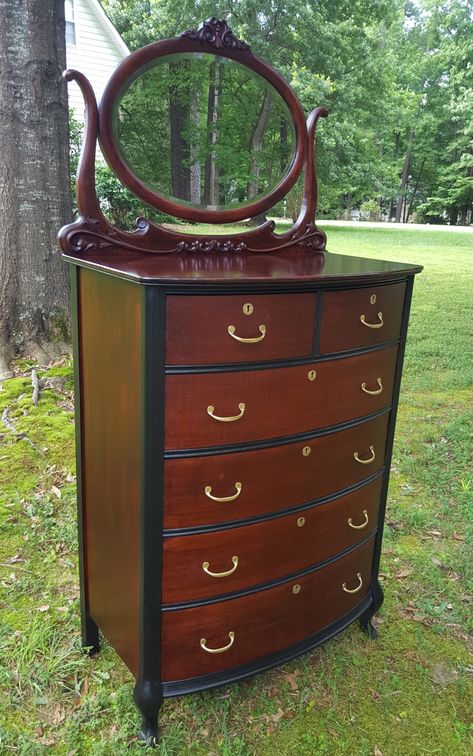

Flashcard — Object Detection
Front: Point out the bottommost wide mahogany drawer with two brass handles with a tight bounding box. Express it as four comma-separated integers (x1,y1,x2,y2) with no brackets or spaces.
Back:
161,539,374,682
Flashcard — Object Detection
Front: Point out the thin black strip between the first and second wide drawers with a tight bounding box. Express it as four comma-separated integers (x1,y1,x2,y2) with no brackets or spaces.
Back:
164,404,391,459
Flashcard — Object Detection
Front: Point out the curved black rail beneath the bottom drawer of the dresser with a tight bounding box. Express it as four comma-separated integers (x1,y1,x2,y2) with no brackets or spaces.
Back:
163,596,372,698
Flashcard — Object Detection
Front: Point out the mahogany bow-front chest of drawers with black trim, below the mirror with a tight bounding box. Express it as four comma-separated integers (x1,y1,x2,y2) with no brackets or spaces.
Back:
60,17,420,744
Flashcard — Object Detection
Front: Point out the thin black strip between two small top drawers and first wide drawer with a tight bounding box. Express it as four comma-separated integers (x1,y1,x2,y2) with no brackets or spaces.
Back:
166,333,399,375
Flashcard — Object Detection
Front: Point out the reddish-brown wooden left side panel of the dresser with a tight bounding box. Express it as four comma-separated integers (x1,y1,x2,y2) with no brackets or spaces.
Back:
79,270,142,673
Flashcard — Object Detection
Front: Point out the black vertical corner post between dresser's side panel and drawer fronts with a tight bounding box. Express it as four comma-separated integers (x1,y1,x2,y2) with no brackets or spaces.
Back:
138,286,166,687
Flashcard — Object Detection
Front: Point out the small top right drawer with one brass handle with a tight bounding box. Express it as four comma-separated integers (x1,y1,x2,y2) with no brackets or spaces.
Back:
320,283,406,354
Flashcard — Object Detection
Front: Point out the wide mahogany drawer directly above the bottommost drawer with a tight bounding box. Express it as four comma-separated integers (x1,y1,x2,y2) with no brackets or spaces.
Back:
163,478,382,604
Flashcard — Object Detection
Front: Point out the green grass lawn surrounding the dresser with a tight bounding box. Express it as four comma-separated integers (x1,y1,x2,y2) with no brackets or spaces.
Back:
0,224,473,756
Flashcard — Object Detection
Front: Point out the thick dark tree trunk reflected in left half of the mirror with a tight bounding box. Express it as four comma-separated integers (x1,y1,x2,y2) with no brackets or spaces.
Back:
169,61,191,202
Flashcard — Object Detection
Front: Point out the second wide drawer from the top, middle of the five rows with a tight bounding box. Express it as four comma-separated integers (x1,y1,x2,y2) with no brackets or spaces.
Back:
164,413,389,528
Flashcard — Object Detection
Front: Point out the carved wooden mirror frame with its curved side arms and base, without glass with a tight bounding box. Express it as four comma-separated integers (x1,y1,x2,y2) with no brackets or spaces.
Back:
59,18,327,255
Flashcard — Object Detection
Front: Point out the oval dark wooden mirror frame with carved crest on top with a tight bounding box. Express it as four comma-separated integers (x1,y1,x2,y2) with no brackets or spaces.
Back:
98,19,307,223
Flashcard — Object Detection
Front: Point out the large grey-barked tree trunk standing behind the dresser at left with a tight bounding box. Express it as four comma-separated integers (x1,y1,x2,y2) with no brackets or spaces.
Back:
0,0,72,374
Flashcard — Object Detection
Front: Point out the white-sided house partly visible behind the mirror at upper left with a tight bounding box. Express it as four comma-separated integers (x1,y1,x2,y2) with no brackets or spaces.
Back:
65,0,130,121
